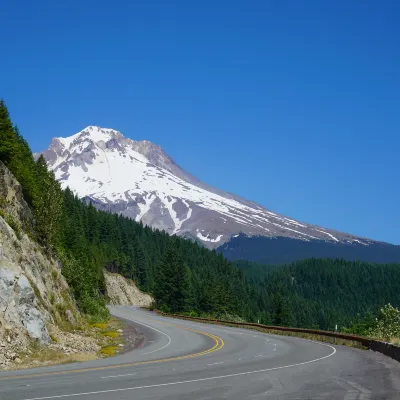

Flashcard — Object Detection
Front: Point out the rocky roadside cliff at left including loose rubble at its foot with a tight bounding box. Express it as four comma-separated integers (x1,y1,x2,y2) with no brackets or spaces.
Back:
0,152,101,369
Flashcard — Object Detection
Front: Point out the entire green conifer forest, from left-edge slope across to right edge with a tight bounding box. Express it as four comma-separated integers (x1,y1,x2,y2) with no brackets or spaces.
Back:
0,101,400,329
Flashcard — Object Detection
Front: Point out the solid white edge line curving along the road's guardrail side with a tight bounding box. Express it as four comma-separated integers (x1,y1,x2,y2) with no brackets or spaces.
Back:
24,340,336,400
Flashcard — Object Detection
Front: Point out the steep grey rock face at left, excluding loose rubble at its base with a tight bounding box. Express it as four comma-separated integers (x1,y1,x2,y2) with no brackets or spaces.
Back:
0,162,82,369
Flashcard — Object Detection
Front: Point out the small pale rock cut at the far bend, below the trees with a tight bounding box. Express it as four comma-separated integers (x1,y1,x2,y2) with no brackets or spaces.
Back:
104,271,153,307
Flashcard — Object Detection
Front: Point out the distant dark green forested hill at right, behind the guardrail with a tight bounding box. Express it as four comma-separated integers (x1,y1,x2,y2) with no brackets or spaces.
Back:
237,259,400,330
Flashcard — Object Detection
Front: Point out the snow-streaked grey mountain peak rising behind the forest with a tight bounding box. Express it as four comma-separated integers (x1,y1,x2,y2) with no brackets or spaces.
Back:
43,126,372,248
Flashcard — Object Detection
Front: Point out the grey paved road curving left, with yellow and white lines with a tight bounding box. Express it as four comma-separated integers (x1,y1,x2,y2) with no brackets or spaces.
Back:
0,306,400,400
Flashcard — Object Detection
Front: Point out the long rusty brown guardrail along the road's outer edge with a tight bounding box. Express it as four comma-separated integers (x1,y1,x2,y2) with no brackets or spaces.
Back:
155,310,400,362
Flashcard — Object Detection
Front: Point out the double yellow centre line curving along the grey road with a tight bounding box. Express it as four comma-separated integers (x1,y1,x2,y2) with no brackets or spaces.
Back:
0,324,225,381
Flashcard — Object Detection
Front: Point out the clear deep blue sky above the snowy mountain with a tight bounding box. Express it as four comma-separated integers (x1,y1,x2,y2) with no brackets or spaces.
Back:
0,0,400,244
